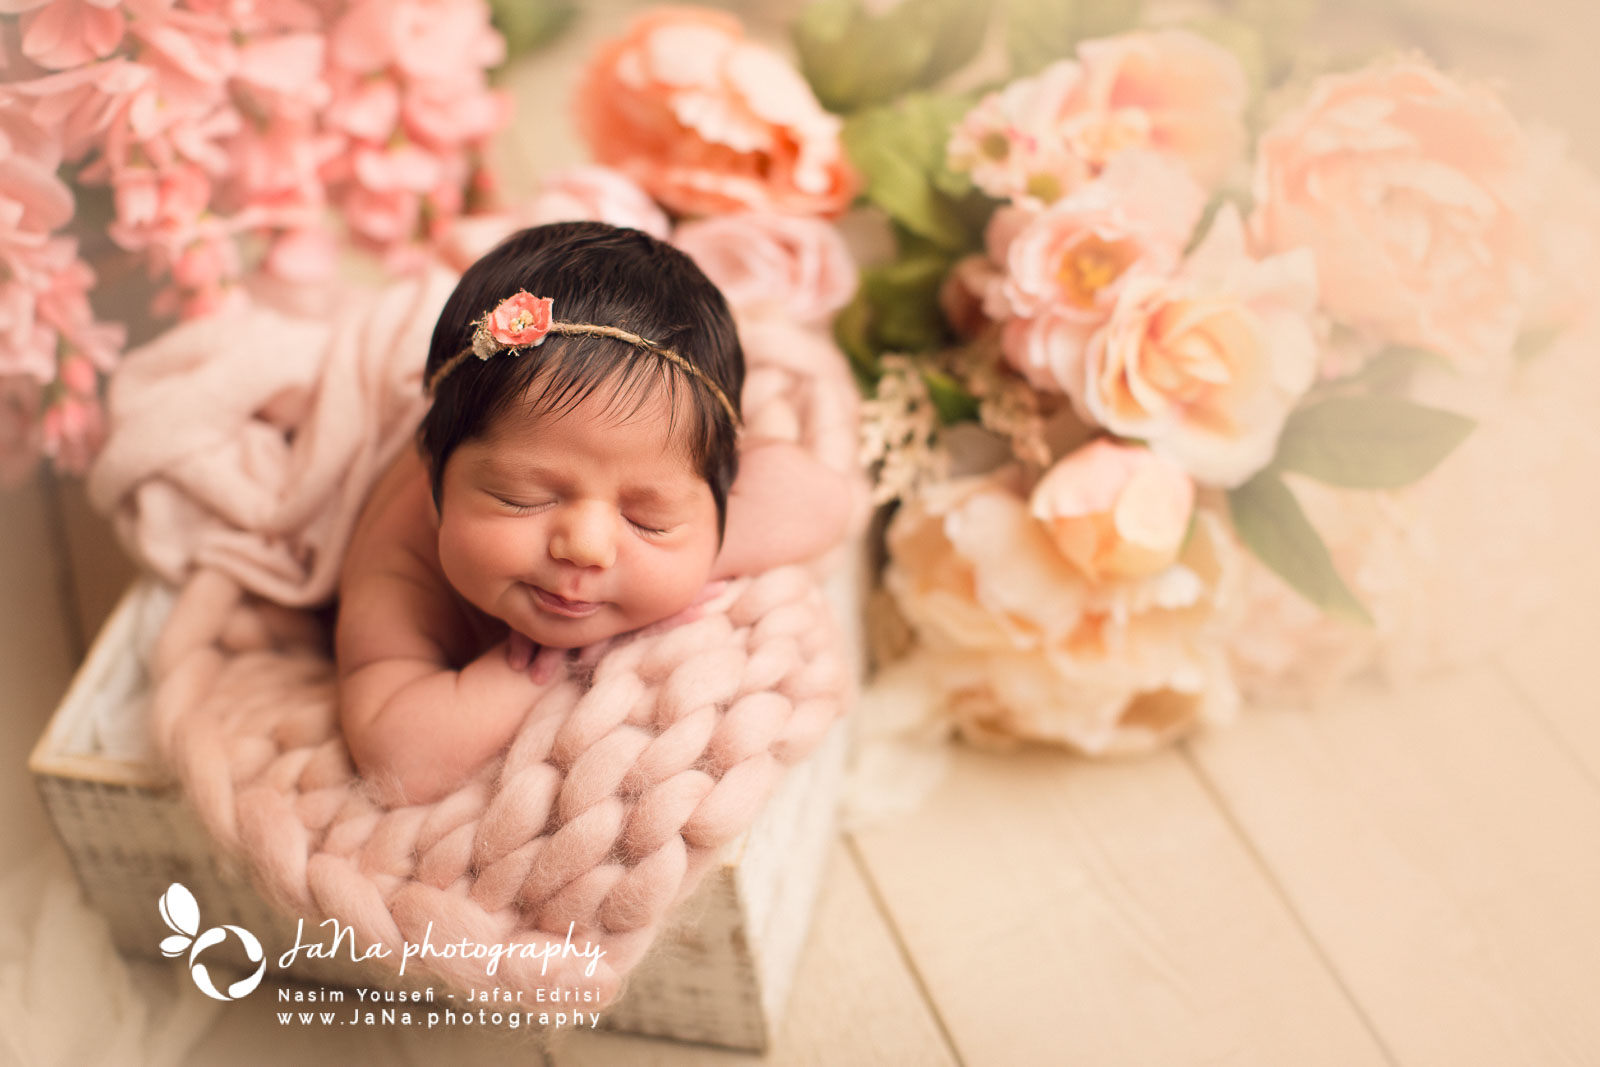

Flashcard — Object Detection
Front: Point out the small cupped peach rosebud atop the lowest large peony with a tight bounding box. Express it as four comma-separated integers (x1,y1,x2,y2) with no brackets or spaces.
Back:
1029,437,1195,582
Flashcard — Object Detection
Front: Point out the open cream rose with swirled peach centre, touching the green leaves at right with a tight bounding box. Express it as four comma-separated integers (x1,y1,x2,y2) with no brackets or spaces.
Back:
1069,206,1317,488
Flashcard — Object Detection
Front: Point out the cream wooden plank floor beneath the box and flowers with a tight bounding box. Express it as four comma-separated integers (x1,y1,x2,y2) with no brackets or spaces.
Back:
9,447,1600,1067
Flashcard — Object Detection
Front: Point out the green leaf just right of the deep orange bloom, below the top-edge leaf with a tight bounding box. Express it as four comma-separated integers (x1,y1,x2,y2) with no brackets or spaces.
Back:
843,94,981,251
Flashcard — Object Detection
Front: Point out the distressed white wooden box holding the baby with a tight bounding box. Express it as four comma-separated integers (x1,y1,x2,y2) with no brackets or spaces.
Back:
29,573,861,1051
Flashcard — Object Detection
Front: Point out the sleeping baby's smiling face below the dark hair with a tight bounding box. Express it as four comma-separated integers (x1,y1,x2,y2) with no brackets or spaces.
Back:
438,386,717,648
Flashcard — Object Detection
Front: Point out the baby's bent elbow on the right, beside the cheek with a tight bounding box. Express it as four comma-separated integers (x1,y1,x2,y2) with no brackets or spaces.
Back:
712,440,853,577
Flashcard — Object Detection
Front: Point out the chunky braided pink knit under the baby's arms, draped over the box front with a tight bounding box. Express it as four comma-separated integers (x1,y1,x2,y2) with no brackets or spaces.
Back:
150,568,853,1008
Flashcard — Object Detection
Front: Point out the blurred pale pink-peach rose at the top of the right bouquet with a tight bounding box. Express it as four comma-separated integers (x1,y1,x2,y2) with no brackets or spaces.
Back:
1064,29,1250,187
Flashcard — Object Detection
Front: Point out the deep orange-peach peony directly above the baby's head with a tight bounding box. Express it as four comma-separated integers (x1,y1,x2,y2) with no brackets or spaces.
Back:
578,8,859,216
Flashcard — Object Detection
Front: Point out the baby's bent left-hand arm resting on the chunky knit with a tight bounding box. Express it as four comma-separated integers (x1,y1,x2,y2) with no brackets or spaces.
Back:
336,573,536,805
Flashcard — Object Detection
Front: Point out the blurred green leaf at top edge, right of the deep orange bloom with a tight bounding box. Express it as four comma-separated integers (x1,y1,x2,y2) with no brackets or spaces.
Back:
794,0,989,114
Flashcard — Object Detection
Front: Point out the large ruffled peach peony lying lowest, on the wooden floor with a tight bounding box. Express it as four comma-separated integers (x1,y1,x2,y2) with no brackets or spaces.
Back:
885,470,1238,755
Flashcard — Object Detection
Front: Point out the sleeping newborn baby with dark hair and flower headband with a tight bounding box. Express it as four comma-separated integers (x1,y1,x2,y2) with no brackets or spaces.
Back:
336,222,850,805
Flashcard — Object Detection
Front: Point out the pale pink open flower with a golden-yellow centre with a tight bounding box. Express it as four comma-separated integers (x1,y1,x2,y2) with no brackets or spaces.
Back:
989,152,1205,323
